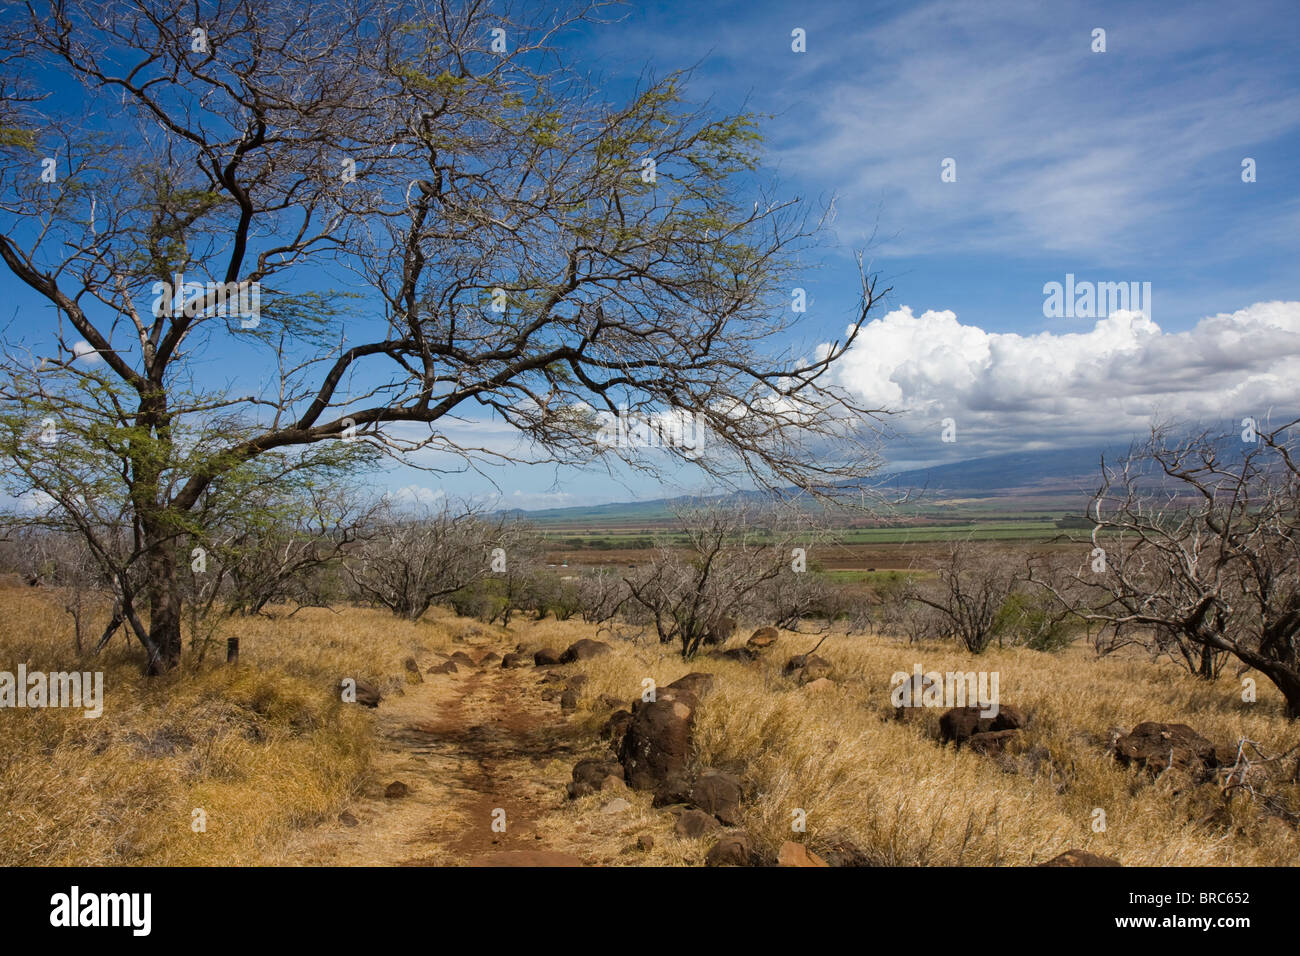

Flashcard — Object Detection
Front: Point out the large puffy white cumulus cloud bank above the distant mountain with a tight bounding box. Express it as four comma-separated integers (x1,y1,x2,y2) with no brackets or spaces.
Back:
836,302,1300,458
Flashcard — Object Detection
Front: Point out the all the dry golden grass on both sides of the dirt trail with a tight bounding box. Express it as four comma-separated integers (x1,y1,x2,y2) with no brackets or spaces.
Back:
0,589,1300,866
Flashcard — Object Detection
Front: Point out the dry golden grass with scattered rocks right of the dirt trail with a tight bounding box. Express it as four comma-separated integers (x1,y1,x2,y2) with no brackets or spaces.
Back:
529,622,1300,866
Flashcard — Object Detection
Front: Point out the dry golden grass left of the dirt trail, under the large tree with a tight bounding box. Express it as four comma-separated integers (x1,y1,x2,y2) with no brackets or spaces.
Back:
0,589,451,865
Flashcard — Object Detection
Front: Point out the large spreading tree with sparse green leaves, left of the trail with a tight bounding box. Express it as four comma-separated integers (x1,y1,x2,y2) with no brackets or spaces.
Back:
0,0,879,672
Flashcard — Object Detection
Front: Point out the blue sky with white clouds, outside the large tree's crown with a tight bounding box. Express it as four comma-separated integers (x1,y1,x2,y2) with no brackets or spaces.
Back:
3,0,1300,507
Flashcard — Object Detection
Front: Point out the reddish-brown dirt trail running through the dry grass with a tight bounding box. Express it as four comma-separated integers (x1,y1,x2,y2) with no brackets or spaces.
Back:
285,639,590,866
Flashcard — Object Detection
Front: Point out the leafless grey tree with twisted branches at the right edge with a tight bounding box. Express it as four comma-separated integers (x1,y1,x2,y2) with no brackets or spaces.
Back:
1039,421,1300,718
